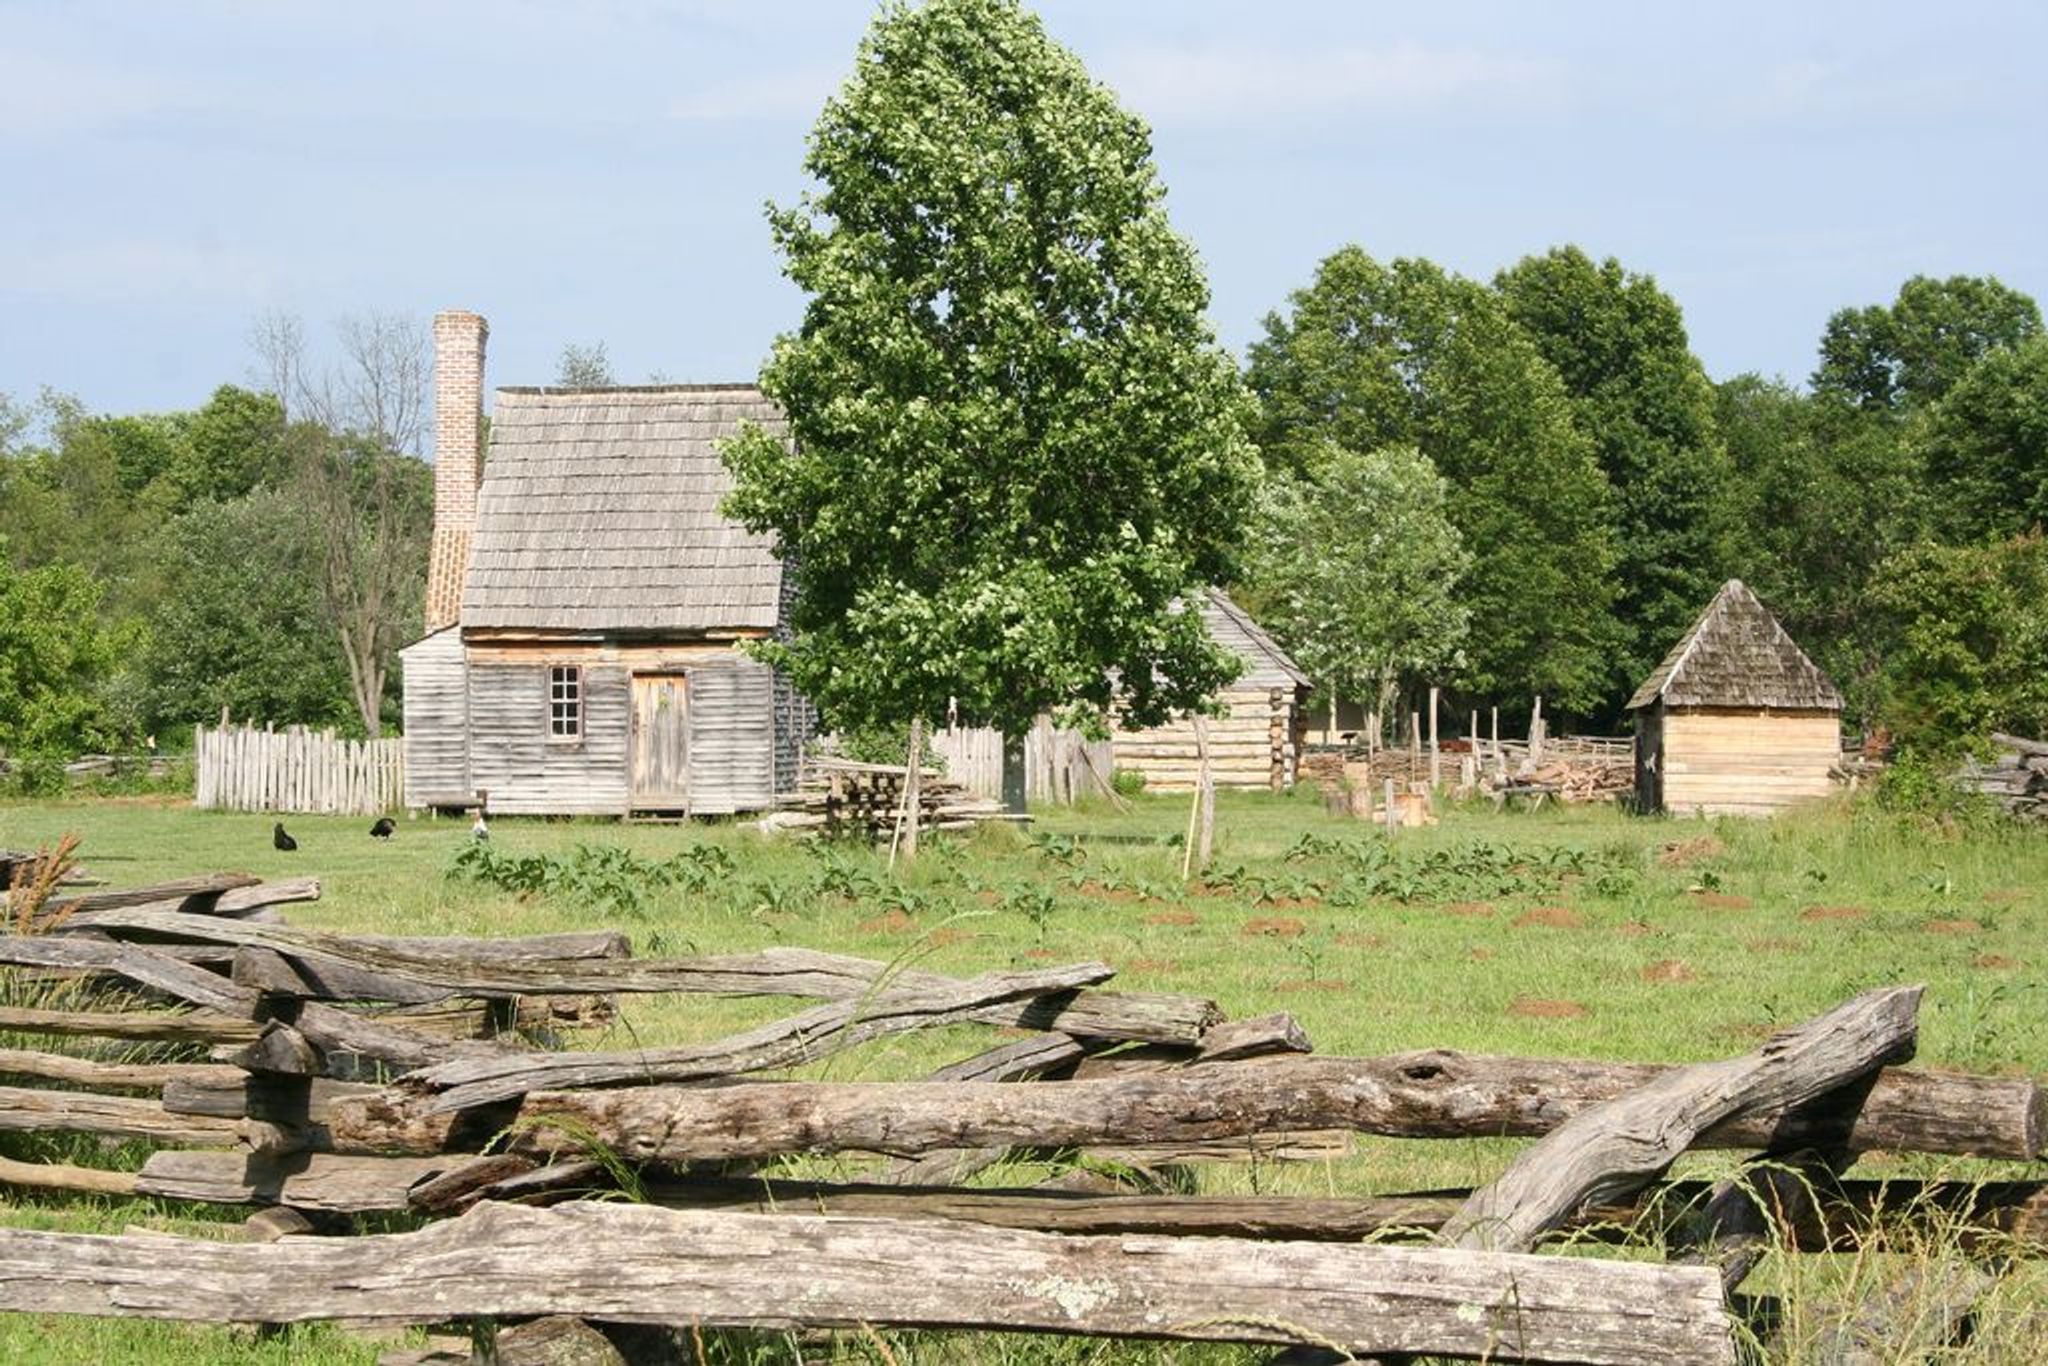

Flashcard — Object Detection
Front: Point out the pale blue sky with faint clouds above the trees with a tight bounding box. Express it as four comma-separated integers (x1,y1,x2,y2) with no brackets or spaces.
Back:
0,0,2048,421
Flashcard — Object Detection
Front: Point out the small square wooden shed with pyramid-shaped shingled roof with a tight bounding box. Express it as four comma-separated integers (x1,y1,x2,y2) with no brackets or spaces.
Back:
1628,580,1841,815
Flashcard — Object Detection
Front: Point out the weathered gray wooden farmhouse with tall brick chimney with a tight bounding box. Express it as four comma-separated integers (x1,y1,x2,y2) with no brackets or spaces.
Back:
399,313,809,815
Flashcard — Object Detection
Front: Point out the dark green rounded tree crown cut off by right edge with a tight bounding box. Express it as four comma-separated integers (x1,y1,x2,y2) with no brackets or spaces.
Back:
1915,336,2048,541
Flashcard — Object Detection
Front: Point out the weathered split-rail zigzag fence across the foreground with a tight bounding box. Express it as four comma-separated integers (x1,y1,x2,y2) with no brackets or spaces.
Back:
0,877,2048,1364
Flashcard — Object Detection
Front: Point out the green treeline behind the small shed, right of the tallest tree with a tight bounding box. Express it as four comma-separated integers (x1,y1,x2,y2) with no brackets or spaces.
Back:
1247,248,2048,743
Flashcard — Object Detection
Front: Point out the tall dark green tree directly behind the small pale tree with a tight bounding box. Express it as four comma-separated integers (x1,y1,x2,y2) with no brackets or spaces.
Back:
1249,246,1616,713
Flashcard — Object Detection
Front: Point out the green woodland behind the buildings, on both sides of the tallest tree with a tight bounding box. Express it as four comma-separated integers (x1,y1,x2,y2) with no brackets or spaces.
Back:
0,258,2048,782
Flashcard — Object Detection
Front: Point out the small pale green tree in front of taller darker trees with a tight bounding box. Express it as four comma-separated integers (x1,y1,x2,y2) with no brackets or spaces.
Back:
1245,446,1473,715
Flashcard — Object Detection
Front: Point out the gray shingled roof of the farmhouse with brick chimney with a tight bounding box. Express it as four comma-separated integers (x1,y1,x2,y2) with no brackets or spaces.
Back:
463,385,784,635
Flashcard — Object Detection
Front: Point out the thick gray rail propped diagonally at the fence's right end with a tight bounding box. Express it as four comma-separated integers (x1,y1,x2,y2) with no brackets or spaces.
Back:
1444,987,1923,1251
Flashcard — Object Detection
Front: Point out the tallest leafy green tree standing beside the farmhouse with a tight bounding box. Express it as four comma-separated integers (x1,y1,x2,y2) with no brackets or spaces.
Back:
725,0,1257,749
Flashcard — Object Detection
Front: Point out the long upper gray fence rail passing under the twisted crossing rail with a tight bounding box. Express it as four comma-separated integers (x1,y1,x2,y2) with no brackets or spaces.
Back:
64,911,1223,1044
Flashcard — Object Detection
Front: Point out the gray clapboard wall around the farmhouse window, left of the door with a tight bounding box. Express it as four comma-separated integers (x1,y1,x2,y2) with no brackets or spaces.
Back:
469,659,631,815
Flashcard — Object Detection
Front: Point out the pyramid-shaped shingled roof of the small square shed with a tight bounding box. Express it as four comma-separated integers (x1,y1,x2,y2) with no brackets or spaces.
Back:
1628,580,1841,711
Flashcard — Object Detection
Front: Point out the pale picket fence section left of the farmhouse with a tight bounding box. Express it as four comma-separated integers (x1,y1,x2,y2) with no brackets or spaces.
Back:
193,725,406,815
